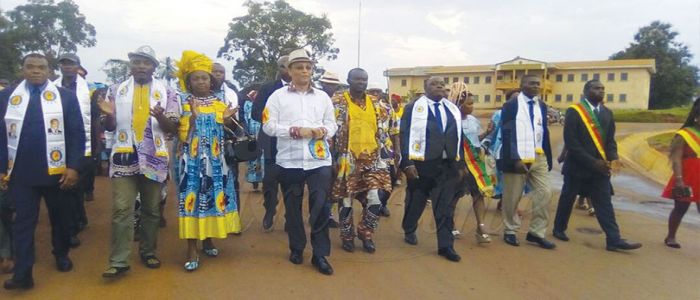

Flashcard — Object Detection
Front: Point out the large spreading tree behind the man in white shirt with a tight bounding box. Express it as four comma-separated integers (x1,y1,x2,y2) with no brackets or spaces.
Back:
218,0,340,86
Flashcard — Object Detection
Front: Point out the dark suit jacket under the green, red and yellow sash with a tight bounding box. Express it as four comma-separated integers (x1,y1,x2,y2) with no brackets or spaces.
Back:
562,105,618,178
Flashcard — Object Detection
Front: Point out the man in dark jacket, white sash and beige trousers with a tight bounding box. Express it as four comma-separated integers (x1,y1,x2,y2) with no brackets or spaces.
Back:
497,74,556,249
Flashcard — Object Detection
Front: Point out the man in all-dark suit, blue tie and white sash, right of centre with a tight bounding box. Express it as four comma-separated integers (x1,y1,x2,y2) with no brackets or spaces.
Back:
400,77,465,262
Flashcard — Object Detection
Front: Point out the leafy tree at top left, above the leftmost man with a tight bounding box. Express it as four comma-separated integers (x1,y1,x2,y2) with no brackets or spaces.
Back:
7,0,97,70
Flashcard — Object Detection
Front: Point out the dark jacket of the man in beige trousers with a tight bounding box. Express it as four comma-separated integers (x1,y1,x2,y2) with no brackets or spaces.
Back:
496,100,552,173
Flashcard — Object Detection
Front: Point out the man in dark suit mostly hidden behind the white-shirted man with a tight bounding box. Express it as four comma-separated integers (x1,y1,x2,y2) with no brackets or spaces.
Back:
251,55,292,232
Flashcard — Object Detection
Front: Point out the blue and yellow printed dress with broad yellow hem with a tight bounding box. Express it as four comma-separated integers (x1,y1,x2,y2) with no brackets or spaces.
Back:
177,95,241,240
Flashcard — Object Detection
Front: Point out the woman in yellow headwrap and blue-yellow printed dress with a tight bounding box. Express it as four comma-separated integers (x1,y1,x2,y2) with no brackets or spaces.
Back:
177,50,241,271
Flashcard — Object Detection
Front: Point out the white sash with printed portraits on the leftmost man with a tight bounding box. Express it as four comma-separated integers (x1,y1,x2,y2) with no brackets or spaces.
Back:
5,81,66,177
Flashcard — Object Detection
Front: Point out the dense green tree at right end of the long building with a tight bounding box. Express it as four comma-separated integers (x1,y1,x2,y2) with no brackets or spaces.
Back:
610,21,698,109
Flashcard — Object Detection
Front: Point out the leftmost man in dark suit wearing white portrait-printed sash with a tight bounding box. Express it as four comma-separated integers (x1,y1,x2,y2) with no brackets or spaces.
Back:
0,54,85,289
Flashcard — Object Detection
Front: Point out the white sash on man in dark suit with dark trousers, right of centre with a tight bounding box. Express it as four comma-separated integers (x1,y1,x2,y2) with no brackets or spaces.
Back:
408,95,462,161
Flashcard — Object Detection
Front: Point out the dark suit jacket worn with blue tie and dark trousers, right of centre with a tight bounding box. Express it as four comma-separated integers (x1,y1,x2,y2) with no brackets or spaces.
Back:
400,101,464,171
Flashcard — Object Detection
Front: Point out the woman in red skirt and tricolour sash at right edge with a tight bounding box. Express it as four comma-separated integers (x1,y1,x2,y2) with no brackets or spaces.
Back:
662,97,700,248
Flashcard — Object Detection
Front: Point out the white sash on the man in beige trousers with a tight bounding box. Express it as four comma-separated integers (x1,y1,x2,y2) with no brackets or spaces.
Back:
515,93,544,163
